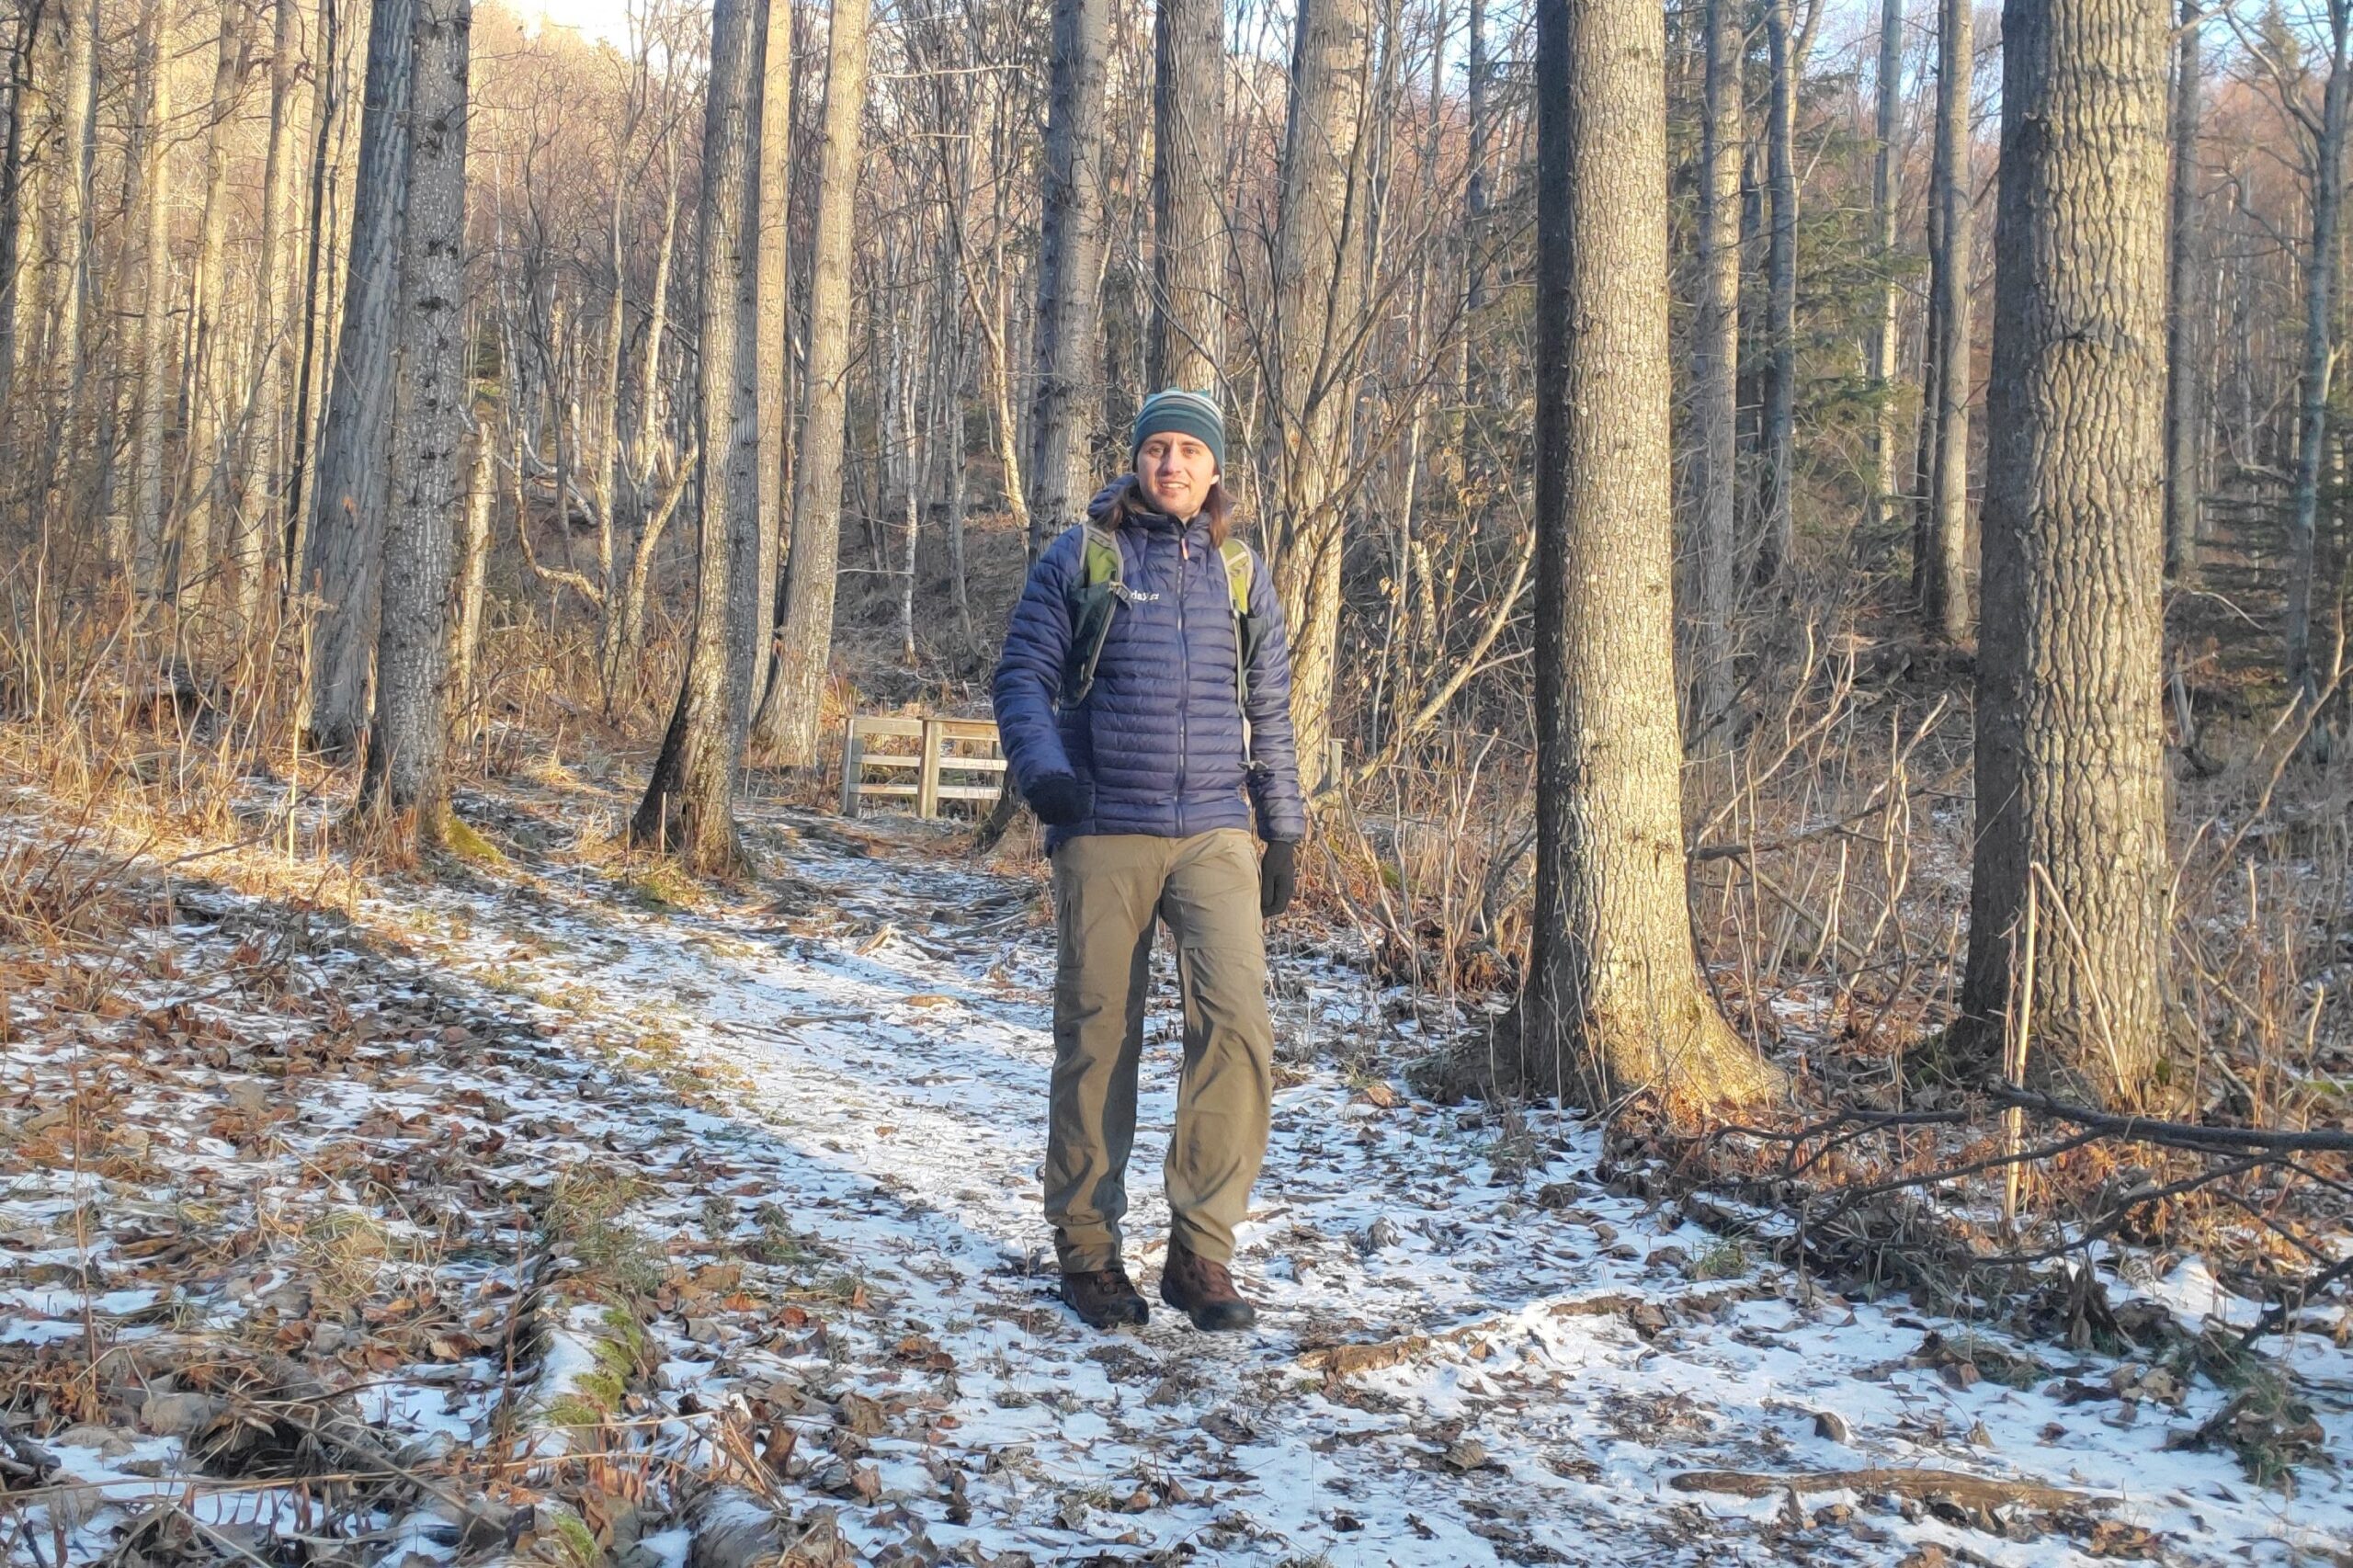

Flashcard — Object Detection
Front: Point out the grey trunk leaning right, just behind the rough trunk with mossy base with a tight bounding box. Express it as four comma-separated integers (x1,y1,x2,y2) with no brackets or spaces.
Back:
301,0,419,758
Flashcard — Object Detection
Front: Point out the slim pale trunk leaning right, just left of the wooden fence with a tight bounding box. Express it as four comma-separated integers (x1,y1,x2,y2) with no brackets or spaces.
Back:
769,0,869,767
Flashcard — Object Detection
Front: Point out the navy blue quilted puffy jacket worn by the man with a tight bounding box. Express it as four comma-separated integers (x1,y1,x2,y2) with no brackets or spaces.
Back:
991,481,1308,847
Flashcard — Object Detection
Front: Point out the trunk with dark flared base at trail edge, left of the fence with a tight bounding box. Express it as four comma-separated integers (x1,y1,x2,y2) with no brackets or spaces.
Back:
631,0,767,873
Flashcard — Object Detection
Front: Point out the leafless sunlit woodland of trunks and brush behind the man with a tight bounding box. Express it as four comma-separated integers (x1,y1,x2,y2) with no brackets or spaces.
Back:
0,0,2353,1431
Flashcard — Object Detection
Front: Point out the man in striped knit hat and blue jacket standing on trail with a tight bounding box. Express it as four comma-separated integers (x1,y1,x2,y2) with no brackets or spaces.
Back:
993,391,1306,1330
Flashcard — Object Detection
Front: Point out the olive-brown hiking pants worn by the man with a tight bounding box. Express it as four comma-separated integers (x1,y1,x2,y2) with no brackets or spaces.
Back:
1045,829,1276,1274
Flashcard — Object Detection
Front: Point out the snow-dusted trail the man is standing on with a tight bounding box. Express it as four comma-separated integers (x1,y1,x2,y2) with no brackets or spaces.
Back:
336,802,2353,1565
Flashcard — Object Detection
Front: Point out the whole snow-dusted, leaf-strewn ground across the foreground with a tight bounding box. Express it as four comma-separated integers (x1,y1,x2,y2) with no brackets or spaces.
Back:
0,770,2353,1568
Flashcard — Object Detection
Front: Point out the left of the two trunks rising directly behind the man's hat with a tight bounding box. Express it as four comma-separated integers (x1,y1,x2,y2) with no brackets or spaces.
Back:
1026,0,1110,558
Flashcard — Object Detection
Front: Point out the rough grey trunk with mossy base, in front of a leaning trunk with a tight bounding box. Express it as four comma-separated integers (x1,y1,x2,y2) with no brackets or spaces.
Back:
360,0,473,846
